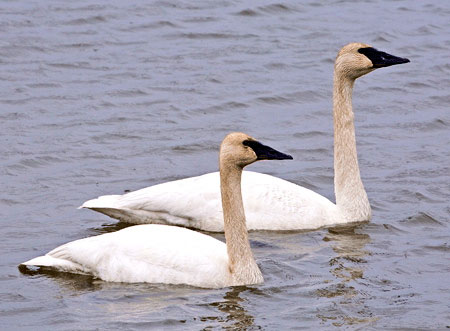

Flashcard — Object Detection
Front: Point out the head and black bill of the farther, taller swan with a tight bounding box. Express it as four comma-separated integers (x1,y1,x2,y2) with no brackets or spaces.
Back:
334,43,409,79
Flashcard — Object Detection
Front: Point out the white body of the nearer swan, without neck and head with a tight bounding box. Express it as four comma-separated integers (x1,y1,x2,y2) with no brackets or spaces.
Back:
23,224,232,288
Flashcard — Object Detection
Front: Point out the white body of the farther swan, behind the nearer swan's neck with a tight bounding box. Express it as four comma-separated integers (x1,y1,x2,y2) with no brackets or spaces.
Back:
82,171,338,232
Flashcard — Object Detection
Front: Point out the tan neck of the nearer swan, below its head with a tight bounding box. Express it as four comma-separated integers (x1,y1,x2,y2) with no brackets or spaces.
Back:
220,164,262,285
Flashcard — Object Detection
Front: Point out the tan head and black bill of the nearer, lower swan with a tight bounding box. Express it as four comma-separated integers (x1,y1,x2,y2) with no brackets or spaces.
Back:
219,132,292,168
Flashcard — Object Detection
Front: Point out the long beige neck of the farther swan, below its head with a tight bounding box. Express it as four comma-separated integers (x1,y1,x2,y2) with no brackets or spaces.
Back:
333,71,371,221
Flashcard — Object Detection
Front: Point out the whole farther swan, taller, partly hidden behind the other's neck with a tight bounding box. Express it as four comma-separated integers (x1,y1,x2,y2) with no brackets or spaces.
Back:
79,43,409,232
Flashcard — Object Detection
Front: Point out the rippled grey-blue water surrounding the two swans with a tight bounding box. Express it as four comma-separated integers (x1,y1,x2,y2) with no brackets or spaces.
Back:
0,0,450,330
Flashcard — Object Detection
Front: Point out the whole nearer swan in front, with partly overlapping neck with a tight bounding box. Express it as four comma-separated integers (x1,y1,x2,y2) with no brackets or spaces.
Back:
19,133,292,288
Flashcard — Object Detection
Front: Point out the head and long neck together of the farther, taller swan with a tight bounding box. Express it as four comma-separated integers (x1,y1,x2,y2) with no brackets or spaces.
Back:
333,43,409,221
